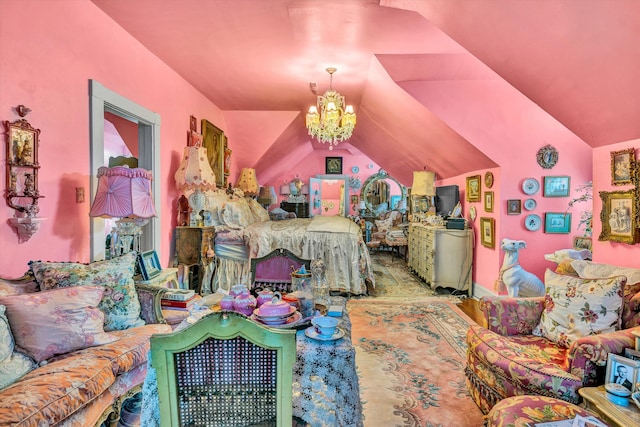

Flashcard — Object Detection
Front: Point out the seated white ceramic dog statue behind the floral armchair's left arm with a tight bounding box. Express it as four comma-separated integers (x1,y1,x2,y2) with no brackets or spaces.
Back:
499,239,544,297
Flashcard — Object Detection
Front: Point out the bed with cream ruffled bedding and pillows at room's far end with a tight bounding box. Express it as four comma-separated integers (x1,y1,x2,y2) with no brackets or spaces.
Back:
203,193,375,295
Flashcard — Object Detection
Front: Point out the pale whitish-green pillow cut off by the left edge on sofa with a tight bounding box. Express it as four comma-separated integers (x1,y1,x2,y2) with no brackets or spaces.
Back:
0,305,36,390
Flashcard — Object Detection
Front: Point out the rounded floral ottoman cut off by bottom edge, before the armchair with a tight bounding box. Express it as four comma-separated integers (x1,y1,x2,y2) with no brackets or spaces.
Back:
485,395,604,427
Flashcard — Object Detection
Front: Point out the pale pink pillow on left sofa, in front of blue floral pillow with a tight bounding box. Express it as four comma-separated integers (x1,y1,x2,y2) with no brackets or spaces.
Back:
0,286,118,362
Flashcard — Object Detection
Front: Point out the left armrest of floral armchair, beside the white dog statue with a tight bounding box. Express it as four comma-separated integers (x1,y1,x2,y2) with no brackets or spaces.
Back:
480,297,544,336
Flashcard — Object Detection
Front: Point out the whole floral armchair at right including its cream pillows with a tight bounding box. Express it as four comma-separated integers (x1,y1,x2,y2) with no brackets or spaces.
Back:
465,260,640,414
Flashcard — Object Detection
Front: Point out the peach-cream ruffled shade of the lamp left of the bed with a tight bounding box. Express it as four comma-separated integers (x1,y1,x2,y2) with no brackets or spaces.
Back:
175,146,216,192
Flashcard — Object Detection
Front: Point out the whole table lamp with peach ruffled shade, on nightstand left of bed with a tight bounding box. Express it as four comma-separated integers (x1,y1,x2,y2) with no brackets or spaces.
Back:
175,146,216,225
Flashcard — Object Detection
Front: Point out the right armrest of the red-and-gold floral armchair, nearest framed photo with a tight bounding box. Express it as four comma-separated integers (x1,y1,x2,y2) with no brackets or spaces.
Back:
566,326,640,371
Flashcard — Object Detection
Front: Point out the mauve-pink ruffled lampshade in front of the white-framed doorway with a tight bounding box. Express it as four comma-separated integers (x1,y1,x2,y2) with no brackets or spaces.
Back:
89,166,156,218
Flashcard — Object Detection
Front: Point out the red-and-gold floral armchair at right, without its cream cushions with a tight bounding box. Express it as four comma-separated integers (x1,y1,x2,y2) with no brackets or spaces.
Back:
465,261,640,414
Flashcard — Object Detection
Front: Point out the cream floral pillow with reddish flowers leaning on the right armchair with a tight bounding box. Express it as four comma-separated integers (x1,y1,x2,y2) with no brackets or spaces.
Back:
533,270,626,347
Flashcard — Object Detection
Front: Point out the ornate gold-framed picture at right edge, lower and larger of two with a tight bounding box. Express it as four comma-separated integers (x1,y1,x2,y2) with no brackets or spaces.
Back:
598,190,638,245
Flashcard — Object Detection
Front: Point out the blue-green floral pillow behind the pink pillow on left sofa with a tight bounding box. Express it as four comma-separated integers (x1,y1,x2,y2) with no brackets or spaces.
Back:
29,252,144,331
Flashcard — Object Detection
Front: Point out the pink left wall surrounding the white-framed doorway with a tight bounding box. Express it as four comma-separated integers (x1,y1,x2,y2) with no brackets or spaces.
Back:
0,0,224,276
